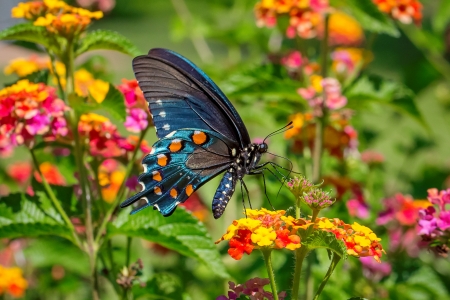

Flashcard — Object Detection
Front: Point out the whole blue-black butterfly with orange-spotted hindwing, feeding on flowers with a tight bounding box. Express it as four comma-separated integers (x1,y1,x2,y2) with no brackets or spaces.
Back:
120,48,284,219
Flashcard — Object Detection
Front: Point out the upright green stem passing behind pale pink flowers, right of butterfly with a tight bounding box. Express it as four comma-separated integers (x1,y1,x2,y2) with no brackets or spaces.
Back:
312,14,330,183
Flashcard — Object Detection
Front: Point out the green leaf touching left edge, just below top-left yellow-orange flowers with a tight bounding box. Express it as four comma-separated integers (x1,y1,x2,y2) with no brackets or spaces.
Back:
0,23,52,49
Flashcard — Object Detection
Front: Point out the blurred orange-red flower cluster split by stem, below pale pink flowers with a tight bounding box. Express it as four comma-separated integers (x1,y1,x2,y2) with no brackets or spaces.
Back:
284,110,358,159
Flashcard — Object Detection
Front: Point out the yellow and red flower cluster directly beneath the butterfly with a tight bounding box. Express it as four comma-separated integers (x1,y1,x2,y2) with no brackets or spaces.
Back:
216,208,311,260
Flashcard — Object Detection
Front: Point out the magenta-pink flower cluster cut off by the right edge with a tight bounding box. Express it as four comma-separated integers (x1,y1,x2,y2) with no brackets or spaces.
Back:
417,189,450,256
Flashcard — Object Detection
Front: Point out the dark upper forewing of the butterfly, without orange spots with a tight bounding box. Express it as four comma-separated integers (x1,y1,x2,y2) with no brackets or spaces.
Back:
133,49,250,148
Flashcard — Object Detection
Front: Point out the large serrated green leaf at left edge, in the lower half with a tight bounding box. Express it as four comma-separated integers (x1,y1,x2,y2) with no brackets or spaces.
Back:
0,192,72,240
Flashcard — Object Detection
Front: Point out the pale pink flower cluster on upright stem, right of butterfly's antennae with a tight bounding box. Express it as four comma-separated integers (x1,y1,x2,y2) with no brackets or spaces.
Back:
297,77,347,116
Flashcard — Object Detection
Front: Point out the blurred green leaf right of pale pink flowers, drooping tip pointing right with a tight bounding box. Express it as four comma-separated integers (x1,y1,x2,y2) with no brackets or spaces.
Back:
344,76,429,130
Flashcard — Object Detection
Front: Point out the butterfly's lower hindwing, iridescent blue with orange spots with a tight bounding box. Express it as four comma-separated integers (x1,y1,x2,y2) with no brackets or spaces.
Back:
120,129,232,216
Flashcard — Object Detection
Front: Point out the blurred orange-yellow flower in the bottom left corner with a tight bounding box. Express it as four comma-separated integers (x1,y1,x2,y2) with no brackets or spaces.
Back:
0,265,28,297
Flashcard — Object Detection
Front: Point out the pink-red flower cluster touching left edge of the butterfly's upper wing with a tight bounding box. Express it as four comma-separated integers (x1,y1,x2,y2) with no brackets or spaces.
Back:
117,79,151,133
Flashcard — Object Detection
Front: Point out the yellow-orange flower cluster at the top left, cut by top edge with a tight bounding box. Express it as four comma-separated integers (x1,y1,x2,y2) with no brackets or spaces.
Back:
12,0,103,38
